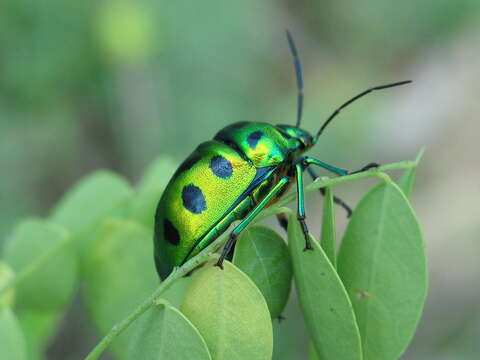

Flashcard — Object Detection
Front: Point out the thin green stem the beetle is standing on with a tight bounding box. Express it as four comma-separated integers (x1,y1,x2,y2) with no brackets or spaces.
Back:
84,155,424,360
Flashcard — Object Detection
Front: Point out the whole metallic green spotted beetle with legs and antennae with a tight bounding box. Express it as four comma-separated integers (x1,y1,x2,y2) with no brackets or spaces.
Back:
154,31,411,279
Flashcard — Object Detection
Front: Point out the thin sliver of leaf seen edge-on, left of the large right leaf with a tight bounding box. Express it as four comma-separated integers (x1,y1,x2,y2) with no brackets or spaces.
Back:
320,186,337,267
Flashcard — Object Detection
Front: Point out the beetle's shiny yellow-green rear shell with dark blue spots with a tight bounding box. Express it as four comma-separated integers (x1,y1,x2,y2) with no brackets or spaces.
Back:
154,141,257,278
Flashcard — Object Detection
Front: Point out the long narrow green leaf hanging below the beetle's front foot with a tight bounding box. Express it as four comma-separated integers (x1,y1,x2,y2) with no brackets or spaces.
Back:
288,216,362,360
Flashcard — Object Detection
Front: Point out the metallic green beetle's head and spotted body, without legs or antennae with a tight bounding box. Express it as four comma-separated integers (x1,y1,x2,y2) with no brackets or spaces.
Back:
154,122,313,278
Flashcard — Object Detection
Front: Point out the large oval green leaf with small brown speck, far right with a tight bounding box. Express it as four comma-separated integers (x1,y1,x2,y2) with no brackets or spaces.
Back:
338,181,427,360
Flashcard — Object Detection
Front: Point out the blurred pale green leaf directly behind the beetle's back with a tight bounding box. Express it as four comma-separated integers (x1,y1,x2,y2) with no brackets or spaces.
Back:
130,157,175,229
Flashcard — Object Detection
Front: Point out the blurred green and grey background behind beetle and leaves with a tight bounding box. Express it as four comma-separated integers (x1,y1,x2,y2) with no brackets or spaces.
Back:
0,0,480,360
